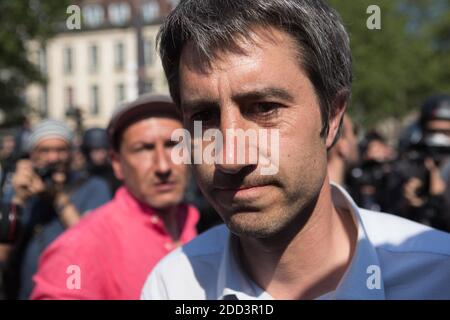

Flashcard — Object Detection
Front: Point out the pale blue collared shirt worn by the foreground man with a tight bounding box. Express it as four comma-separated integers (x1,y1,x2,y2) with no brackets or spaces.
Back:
141,184,450,300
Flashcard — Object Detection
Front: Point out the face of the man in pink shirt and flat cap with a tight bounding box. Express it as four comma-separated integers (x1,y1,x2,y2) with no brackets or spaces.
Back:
112,117,188,209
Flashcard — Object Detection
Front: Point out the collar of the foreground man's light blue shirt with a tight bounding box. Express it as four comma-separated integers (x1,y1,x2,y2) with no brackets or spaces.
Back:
217,183,385,300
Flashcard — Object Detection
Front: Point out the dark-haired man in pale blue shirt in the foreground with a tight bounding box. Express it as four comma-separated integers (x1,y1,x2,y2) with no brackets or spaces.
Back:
141,0,450,299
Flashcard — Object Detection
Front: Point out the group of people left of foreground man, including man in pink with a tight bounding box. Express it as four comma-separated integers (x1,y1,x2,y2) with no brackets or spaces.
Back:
0,94,218,299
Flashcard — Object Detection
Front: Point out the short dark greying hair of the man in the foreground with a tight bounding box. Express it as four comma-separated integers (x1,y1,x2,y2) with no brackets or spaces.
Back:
157,0,352,136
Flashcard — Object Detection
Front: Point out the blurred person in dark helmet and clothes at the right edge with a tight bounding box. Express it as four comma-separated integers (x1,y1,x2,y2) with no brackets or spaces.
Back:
393,95,450,231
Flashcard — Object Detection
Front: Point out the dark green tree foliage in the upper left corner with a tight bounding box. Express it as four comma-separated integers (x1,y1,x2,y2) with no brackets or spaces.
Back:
0,0,67,126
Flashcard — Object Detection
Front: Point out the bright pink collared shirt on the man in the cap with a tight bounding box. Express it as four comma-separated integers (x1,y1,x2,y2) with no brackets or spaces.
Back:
31,187,199,299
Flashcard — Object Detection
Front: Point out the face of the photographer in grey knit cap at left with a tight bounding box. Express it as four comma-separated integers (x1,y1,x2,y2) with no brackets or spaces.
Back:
31,138,70,171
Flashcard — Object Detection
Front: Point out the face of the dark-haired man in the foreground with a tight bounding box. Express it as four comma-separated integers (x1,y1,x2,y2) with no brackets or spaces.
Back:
180,29,342,238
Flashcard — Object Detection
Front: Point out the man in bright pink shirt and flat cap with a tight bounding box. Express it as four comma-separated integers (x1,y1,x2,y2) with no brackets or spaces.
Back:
31,95,199,299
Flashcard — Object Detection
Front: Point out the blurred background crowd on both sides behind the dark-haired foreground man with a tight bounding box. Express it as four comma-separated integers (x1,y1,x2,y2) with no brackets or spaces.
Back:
0,71,450,299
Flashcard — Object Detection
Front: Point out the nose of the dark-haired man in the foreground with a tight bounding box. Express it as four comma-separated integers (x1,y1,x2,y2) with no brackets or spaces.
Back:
216,110,256,174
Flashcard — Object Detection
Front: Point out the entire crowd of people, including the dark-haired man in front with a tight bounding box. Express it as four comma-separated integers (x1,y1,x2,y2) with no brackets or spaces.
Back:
0,0,450,299
